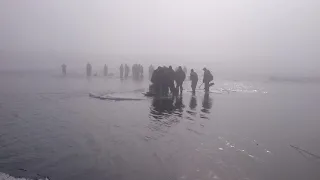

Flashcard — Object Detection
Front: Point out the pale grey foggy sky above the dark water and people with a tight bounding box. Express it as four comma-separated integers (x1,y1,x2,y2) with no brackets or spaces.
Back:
0,0,320,72
